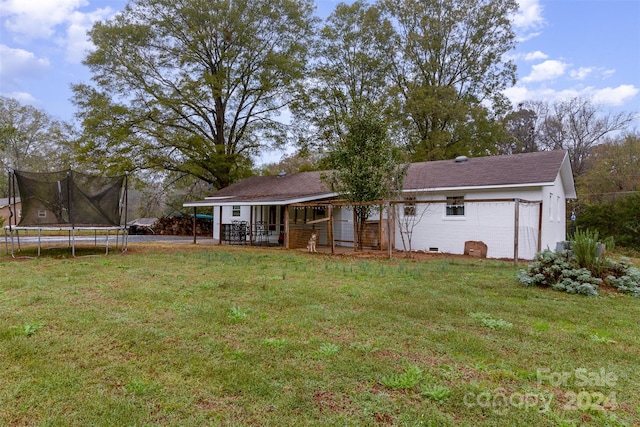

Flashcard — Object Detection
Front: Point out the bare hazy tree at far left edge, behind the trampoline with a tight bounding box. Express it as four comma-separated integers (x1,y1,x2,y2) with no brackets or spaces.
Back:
0,96,72,196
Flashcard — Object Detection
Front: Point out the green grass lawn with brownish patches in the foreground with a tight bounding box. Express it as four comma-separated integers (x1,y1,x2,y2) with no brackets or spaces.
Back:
0,245,640,426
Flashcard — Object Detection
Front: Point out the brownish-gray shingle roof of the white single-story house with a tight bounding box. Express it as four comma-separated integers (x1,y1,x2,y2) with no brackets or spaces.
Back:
186,150,573,206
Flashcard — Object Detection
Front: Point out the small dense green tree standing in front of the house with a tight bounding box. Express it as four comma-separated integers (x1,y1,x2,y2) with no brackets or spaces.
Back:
323,107,407,250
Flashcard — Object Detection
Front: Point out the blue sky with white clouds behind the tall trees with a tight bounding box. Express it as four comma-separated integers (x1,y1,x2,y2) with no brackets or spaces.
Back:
0,0,640,127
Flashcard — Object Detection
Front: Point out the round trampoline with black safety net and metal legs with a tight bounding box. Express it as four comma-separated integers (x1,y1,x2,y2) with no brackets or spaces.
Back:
4,169,128,257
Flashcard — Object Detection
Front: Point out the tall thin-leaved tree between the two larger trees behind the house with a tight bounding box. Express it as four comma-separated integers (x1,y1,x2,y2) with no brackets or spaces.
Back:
293,0,395,149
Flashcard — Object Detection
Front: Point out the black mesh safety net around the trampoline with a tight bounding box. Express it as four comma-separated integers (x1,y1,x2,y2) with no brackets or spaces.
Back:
13,170,125,226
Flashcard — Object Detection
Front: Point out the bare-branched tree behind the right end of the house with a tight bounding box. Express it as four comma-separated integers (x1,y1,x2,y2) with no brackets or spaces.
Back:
539,98,636,175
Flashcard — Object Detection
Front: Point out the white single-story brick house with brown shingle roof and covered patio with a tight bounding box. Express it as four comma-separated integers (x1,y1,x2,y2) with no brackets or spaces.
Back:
184,150,576,259
